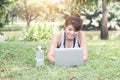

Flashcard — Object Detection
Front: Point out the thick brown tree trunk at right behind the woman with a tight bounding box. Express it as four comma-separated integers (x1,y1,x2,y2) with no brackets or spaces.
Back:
101,0,109,40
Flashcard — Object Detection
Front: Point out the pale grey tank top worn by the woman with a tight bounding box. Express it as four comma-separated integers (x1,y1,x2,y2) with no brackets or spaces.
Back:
58,31,80,48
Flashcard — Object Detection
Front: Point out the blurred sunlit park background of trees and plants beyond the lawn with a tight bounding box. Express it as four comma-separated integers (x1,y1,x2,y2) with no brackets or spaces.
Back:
0,0,120,41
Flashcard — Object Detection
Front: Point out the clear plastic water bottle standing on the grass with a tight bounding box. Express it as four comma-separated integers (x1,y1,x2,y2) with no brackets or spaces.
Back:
36,46,44,66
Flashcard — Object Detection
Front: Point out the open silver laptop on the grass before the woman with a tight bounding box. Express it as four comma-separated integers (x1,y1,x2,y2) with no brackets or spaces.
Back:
55,48,83,67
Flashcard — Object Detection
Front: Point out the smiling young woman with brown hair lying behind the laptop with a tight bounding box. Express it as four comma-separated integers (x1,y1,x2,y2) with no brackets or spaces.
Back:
47,13,88,62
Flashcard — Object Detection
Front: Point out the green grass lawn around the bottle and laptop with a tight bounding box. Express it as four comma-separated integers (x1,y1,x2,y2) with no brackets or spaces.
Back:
0,39,120,80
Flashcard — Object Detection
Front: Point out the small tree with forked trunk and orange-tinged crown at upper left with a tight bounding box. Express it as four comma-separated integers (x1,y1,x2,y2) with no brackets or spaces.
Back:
14,0,41,27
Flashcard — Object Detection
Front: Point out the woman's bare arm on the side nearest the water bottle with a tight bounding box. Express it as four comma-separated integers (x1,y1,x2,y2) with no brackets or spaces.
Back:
47,34,58,62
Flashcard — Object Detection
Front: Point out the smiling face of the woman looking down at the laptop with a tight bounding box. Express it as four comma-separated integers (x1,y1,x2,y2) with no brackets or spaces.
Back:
65,25,78,40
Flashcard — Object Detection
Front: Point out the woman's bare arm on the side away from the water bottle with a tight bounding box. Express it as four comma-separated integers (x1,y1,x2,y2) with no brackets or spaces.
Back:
80,31,88,61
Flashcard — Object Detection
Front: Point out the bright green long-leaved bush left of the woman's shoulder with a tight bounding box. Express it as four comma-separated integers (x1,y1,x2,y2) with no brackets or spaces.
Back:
23,24,55,41
